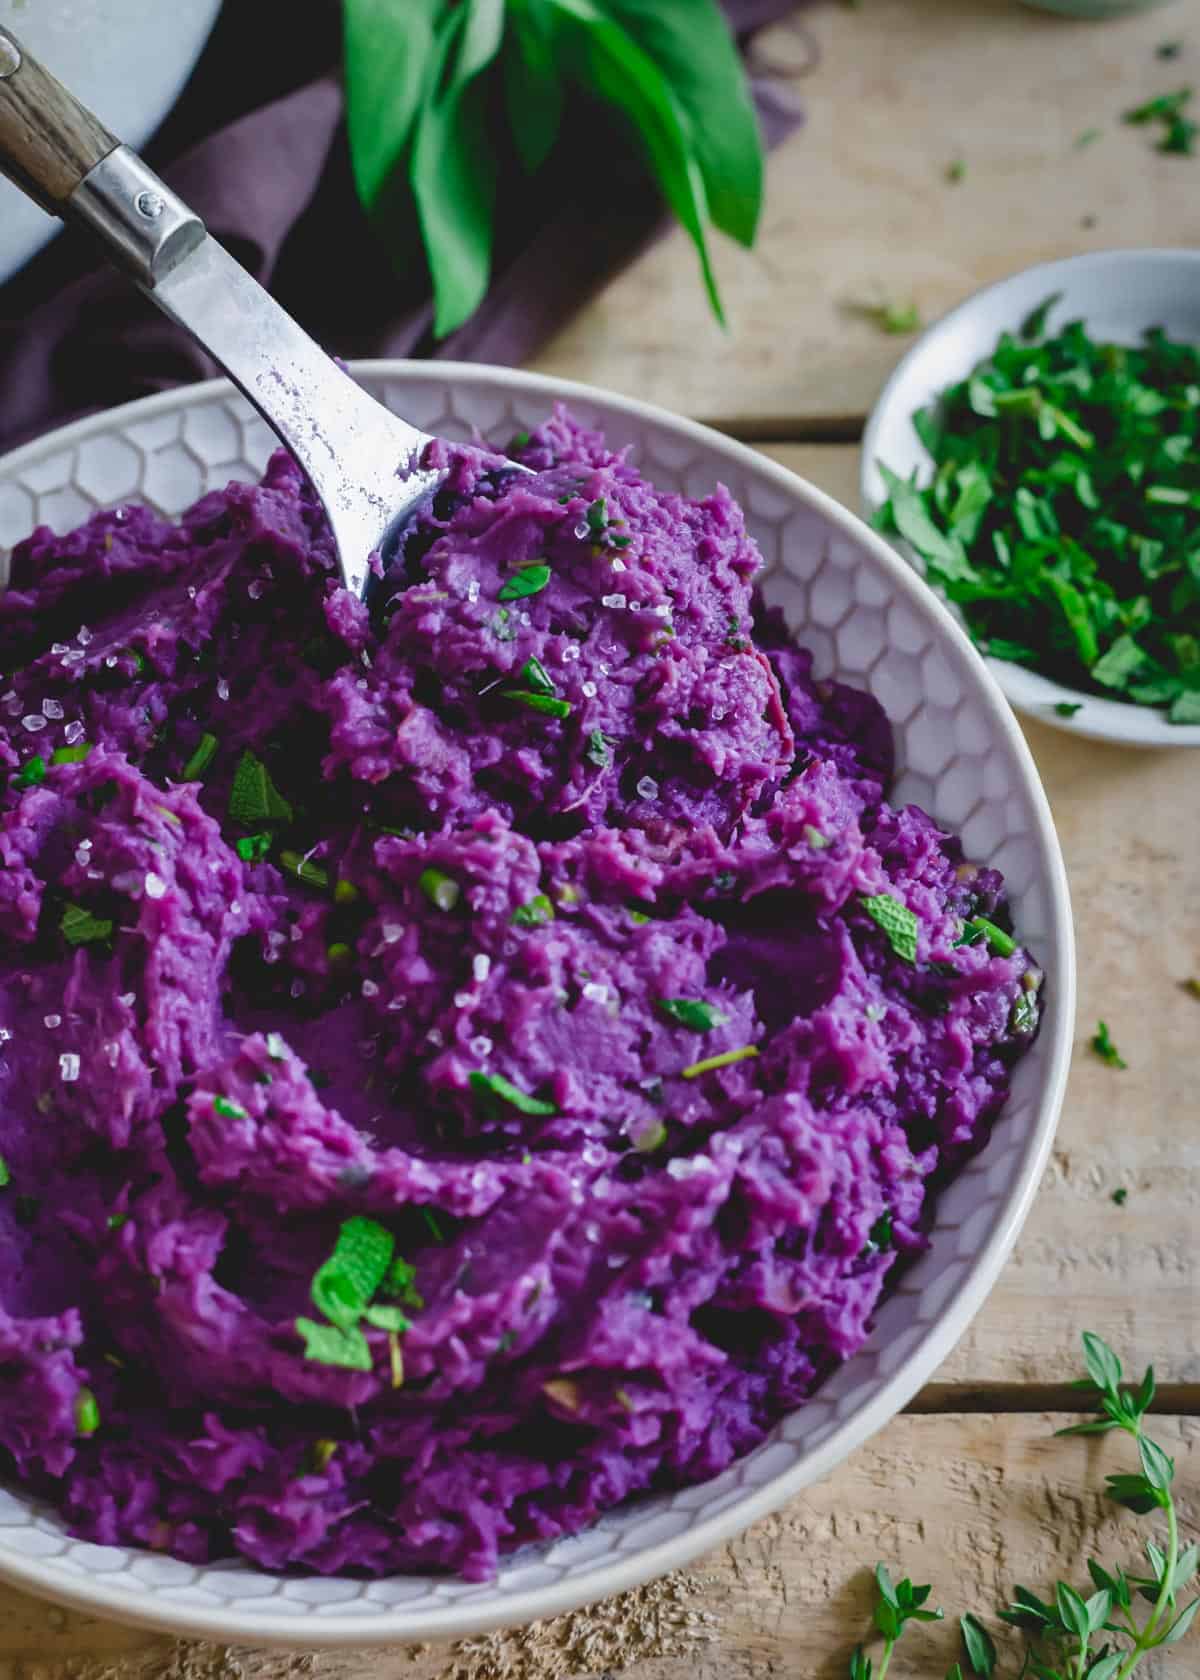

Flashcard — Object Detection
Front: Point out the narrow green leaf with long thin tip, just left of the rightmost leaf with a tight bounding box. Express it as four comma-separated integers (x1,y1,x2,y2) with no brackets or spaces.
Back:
550,0,724,324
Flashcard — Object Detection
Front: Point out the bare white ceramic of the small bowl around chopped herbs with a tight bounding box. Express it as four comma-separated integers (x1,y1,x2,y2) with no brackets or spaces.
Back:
861,250,1200,746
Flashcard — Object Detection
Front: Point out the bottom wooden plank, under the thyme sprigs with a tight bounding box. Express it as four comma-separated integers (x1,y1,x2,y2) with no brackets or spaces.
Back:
0,1415,1200,1680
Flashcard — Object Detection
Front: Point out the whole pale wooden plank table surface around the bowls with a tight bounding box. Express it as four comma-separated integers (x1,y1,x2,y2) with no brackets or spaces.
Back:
9,0,1200,1680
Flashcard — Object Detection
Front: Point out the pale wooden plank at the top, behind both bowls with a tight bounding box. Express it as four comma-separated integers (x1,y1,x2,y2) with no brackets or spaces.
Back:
533,0,1200,437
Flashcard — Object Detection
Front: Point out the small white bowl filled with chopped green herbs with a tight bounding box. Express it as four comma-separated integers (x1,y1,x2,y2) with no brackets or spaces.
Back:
864,250,1200,746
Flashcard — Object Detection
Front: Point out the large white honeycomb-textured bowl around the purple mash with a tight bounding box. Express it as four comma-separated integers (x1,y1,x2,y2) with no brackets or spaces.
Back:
0,363,1074,1646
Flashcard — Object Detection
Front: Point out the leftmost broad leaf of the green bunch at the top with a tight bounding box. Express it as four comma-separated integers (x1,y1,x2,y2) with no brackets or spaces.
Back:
342,0,445,210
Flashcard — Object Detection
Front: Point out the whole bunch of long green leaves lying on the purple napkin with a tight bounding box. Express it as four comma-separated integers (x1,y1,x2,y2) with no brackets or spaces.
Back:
343,0,763,338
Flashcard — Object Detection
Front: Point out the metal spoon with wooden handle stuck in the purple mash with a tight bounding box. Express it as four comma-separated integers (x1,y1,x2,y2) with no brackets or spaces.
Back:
0,25,490,598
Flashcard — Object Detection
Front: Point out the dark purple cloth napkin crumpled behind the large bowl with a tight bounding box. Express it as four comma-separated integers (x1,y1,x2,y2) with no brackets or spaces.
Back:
0,0,802,450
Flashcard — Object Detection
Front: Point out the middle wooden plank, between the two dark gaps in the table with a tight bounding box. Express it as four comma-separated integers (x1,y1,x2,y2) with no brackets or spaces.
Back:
766,445,1200,1384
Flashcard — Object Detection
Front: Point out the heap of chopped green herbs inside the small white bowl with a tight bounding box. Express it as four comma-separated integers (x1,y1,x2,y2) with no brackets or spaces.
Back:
876,315,1200,722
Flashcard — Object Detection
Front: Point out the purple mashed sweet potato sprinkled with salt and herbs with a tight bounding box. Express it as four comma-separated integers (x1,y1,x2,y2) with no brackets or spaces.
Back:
0,413,1040,1579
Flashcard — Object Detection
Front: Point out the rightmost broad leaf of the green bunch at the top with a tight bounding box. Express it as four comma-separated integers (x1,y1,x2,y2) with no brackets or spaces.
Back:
605,0,763,245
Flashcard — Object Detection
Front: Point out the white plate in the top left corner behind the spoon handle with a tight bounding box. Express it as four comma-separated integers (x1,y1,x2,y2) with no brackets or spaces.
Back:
0,0,220,281
